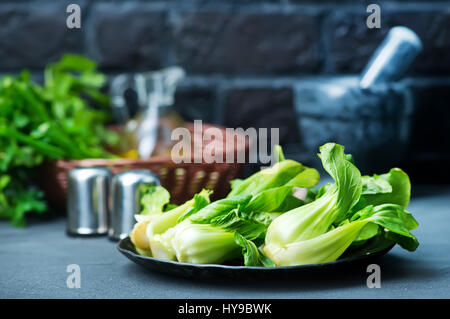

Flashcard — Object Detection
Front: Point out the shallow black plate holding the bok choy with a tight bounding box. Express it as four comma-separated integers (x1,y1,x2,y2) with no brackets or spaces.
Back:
117,237,394,279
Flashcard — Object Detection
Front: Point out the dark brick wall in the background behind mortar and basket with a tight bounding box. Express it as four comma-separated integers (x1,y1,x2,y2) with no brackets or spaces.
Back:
0,0,450,181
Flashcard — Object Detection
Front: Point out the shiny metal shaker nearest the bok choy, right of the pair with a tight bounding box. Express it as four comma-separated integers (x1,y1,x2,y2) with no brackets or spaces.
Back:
108,170,160,240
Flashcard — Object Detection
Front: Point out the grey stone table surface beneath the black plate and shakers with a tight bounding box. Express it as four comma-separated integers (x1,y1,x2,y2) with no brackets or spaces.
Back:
0,187,450,298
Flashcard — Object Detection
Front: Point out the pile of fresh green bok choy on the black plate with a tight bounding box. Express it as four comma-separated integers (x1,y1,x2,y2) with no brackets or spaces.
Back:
130,143,419,267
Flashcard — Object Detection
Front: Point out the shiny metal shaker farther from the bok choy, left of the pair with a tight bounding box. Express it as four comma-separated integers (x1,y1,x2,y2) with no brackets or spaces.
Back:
67,167,112,235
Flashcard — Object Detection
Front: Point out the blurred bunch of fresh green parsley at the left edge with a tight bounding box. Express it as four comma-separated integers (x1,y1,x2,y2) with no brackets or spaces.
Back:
0,54,118,226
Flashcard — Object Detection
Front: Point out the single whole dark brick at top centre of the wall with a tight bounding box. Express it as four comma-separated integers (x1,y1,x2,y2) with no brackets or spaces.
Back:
174,9,319,74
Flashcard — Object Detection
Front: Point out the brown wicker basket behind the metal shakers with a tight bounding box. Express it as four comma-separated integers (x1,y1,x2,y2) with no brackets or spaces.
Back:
39,123,249,207
